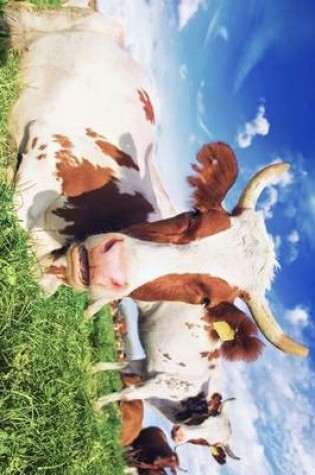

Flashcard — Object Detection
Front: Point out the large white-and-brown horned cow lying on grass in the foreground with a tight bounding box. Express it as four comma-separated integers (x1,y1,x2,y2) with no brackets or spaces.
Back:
7,1,307,356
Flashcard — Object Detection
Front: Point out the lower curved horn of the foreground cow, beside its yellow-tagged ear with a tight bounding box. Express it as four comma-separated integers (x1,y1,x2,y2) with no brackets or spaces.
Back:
244,297,308,356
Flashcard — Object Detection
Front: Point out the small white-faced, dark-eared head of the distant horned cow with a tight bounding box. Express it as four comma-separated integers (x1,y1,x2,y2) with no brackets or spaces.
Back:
172,393,239,465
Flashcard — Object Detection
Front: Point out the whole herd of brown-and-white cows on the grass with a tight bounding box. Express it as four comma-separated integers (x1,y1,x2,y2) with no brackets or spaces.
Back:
7,0,307,474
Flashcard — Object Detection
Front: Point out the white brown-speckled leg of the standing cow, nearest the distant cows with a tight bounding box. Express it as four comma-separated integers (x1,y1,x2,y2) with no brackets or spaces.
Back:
94,374,198,411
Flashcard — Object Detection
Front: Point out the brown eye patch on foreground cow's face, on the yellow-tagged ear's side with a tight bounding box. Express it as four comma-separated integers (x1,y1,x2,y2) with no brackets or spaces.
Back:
131,274,238,306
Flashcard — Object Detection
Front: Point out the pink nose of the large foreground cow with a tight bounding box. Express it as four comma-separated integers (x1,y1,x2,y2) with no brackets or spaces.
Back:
89,237,128,291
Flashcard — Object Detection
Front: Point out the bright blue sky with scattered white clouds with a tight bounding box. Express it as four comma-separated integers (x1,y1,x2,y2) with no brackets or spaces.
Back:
99,0,315,475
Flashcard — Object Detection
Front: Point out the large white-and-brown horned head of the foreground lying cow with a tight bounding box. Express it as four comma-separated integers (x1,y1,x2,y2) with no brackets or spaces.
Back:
67,143,307,356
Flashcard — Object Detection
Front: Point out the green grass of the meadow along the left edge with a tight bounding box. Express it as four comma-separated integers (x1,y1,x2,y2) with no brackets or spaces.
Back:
0,0,124,475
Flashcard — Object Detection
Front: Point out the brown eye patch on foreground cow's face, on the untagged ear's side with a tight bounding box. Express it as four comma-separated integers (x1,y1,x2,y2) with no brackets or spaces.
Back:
125,209,231,244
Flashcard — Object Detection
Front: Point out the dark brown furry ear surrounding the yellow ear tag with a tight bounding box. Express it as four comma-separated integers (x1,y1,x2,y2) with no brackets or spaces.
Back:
206,302,264,362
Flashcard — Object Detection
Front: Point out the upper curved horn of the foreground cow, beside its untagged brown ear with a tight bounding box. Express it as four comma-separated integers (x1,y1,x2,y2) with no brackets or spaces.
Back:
236,162,290,211
